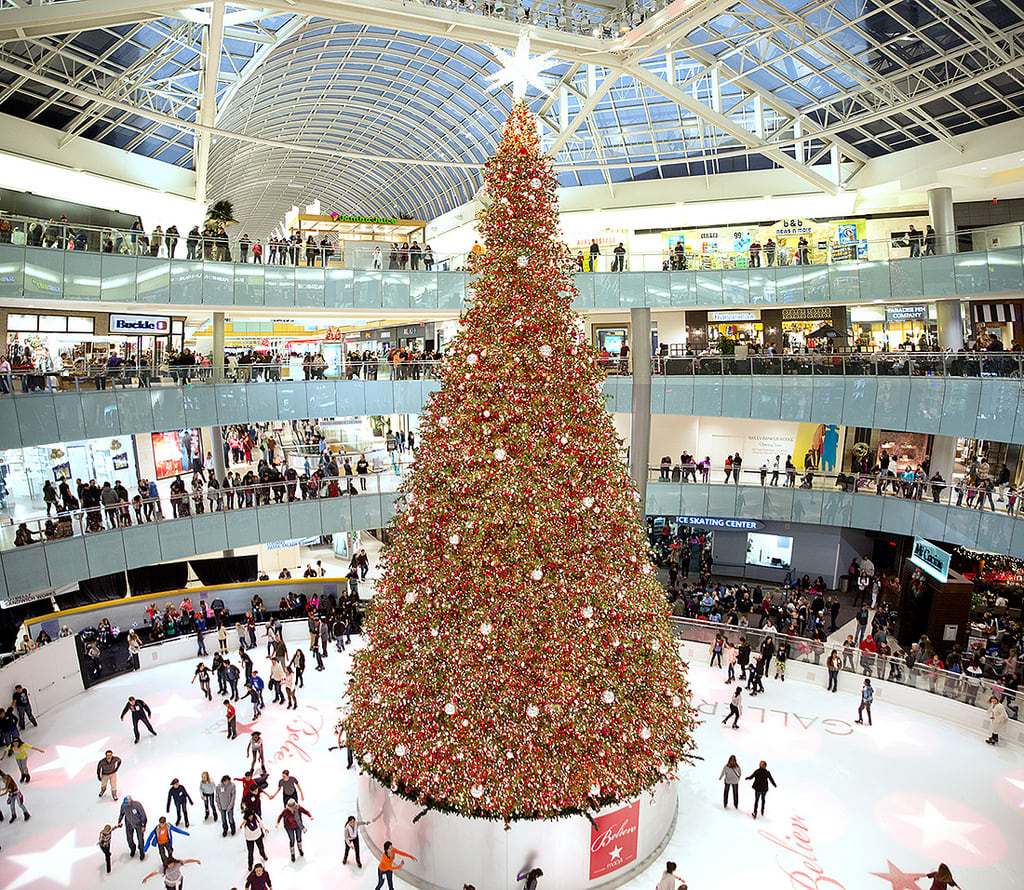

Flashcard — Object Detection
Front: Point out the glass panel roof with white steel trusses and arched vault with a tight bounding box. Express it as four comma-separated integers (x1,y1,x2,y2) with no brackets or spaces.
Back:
0,0,1024,228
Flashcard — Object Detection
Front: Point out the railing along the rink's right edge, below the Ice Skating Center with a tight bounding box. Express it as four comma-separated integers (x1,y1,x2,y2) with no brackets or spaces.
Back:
672,617,1024,720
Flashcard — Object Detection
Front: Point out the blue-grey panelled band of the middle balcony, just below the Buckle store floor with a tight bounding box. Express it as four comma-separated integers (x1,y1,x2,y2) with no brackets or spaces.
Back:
0,352,1024,450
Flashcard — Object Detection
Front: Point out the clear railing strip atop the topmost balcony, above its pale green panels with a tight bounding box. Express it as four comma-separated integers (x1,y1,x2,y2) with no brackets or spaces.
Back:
0,215,1024,272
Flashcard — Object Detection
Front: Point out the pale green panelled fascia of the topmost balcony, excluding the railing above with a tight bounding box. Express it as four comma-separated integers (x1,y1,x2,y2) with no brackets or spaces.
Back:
0,244,1024,312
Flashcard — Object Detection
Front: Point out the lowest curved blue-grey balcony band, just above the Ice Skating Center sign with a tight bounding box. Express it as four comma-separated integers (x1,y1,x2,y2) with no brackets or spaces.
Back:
6,467,1024,600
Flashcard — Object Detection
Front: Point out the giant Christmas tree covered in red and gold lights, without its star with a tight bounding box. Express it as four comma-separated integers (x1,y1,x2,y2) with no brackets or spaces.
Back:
346,102,694,819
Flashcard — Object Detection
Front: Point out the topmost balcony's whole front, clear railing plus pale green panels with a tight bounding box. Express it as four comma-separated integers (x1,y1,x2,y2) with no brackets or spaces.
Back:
0,218,1024,311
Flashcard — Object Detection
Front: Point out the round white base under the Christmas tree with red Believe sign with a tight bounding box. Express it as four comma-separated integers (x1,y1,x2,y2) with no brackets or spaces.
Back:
358,772,679,890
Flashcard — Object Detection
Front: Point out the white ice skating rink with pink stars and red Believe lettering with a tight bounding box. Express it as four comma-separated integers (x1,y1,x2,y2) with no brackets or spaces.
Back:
0,649,1024,890
